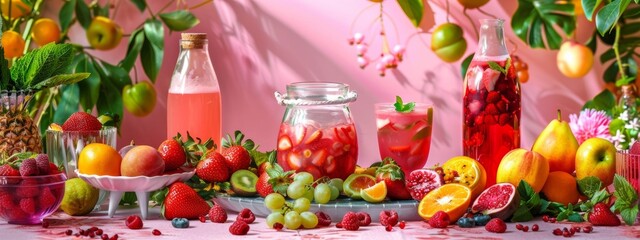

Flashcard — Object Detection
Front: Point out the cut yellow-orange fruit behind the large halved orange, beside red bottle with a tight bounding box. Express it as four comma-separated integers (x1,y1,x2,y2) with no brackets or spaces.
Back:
442,156,487,199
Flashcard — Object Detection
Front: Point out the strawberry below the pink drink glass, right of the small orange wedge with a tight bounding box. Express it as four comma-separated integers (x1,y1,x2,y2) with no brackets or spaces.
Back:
376,158,411,200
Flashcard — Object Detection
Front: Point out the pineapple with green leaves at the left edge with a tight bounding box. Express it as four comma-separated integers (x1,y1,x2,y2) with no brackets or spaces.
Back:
0,44,89,155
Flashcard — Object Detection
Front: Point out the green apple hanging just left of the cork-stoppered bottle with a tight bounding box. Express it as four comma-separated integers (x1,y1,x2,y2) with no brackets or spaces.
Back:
122,81,156,117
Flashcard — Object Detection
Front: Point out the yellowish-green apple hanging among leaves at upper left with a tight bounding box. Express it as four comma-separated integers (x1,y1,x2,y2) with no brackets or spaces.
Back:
87,16,122,50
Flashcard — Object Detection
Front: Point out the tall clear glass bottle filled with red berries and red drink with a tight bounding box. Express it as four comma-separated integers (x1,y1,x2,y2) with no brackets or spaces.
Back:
462,19,521,187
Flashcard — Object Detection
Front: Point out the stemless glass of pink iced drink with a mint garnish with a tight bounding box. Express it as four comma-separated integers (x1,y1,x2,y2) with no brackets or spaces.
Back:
375,103,433,174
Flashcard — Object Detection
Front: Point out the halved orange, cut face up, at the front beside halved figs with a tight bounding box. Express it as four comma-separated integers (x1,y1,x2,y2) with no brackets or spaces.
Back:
418,183,471,223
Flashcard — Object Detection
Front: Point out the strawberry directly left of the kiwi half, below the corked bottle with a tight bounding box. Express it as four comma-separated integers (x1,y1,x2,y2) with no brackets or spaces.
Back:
196,152,229,183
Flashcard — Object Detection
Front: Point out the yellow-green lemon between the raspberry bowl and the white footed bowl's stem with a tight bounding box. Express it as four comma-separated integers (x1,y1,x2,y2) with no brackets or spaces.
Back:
60,178,100,216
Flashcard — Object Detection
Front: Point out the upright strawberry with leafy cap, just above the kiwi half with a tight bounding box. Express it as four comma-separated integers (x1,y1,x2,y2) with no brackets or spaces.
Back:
222,131,254,173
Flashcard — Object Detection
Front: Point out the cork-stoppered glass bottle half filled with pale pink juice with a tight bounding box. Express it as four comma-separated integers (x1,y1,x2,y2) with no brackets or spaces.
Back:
167,33,222,144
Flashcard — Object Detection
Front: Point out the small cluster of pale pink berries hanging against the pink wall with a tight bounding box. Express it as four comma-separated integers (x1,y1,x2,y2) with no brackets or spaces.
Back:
347,32,405,76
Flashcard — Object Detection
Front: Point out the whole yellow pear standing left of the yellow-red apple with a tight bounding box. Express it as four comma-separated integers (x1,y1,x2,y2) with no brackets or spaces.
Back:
531,109,580,174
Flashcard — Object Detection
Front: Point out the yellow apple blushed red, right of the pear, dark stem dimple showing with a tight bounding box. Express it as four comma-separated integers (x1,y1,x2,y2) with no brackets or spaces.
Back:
576,138,616,187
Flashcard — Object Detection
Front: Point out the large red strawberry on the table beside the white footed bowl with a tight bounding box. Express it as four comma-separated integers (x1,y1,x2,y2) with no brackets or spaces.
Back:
162,182,211,220
